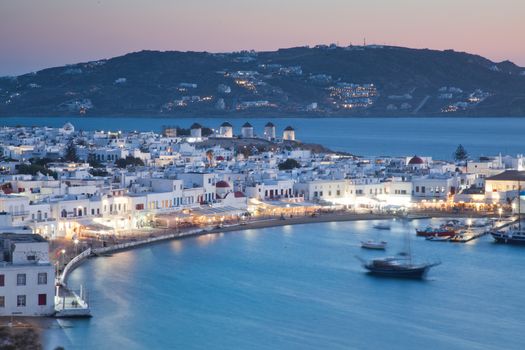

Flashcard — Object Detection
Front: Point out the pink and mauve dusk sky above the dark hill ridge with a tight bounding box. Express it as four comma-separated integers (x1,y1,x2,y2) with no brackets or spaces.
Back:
0,0,525,76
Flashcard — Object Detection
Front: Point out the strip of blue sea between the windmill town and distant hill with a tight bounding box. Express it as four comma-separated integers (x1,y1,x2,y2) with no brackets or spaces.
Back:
4,117,525,159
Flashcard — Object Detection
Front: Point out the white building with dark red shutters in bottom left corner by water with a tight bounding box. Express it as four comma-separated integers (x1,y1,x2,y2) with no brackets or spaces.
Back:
0,233,55,316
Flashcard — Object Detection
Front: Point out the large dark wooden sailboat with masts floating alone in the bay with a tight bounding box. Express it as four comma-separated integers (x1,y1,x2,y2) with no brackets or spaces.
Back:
358,227,440,279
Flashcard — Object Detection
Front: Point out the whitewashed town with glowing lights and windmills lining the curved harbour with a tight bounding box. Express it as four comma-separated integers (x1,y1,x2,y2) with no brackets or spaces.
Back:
0,121,525,316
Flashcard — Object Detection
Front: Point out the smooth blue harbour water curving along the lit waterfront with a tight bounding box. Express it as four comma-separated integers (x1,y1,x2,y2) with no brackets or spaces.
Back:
45,220,525,350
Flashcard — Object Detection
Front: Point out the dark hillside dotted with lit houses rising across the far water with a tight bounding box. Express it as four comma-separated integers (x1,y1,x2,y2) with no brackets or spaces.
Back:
0,45,525,116
